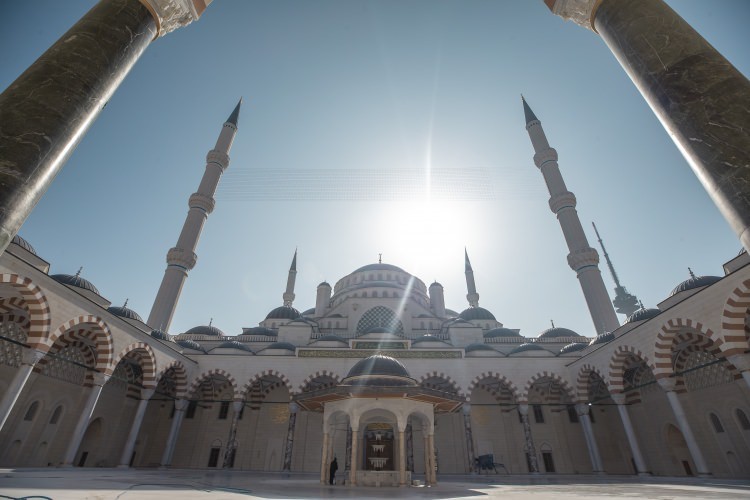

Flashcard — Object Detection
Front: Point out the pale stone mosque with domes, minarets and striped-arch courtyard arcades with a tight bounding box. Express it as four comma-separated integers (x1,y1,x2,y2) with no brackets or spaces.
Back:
0,95,750,486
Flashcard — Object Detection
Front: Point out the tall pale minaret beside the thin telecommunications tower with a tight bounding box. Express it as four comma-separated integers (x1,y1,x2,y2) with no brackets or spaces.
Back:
521,96,620,334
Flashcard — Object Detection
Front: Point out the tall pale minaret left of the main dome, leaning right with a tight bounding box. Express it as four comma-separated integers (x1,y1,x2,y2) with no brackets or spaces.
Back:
148,99,247,332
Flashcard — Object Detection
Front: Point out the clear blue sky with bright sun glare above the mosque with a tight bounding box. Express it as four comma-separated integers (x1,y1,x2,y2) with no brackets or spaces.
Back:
0,0,750,337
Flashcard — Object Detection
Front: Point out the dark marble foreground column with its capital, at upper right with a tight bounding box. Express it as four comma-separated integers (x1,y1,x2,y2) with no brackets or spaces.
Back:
547,0,750,249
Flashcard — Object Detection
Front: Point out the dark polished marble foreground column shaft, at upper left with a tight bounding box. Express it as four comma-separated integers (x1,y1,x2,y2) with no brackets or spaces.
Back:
0,0,156,253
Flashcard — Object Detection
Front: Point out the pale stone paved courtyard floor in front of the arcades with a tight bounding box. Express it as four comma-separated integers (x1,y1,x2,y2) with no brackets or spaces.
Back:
0,468,750,500
